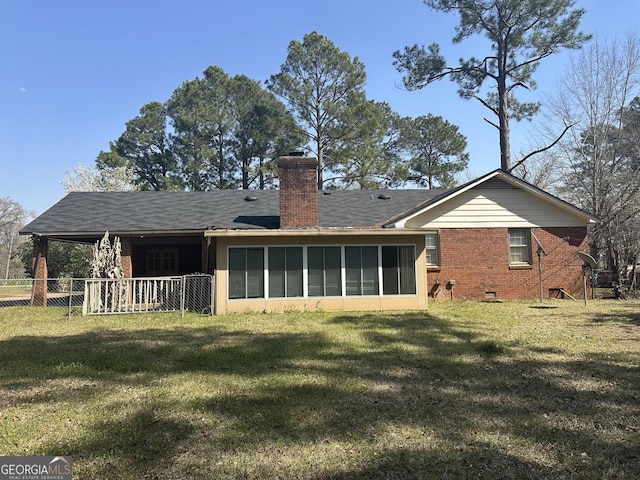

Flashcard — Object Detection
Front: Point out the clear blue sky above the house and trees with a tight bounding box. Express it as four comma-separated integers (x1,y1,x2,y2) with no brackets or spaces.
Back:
0,0,640,214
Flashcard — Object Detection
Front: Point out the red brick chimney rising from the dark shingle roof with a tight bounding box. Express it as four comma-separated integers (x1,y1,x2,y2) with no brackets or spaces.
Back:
278,152,318,228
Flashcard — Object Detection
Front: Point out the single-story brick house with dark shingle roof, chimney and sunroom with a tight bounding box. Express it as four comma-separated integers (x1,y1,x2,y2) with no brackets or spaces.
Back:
21,154,597,314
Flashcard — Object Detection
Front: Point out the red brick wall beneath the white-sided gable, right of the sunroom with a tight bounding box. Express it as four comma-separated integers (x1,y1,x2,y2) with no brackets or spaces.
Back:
427,227,590,300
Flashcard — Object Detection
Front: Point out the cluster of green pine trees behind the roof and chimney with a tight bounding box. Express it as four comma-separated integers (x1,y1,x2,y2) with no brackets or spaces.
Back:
96,32,469,191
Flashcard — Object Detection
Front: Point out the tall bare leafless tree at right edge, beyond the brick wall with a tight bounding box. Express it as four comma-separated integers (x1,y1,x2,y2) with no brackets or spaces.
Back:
551,35,640,296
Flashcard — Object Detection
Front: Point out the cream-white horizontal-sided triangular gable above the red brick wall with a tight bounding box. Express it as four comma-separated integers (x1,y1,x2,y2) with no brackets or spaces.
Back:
404,178,590,229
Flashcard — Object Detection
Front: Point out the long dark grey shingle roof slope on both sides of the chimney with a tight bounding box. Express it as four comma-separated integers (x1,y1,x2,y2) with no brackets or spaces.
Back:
21,189,442,236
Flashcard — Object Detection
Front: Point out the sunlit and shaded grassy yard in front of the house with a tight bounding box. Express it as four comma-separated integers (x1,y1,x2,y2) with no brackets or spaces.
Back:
0,301,640,480
